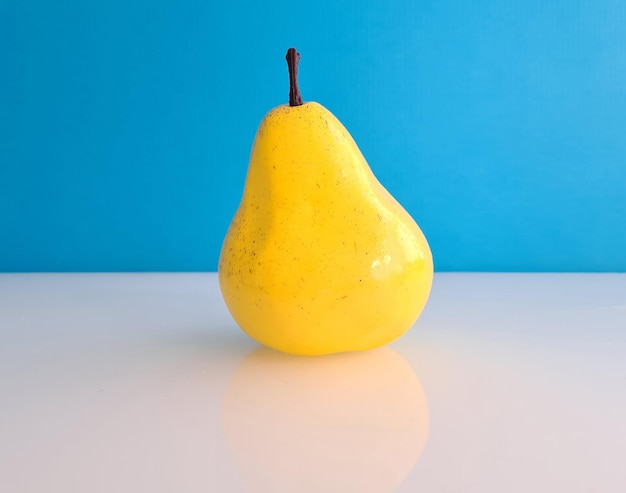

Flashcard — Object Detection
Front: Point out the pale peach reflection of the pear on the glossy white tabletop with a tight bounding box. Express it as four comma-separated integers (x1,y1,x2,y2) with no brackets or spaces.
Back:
222,348,428,492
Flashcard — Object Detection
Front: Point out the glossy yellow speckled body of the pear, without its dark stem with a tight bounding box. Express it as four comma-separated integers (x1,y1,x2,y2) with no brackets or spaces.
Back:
218,102,433,355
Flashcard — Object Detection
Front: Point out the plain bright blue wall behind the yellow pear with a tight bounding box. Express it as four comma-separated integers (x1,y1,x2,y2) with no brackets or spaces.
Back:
0,0,626,271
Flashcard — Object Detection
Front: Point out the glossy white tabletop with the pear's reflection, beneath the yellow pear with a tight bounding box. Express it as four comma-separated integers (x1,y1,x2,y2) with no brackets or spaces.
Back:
0,274,626,493
